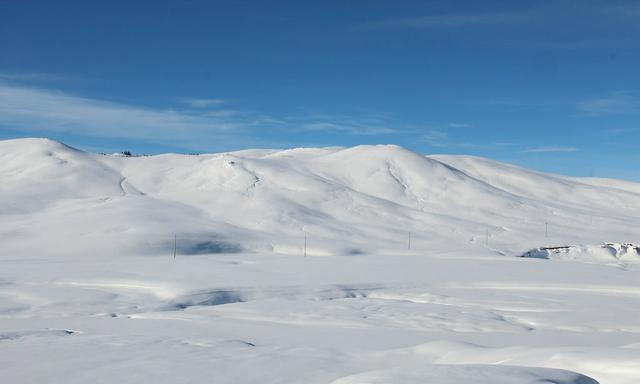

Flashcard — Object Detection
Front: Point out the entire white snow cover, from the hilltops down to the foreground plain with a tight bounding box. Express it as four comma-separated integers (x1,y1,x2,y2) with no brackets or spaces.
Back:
0,139,640,384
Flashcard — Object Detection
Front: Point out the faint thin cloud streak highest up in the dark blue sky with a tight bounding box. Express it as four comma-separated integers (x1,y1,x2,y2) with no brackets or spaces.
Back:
361,10,535,30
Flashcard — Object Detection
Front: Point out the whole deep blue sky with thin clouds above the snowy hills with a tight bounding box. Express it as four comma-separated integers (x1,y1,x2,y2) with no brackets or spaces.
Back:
0,0,640,181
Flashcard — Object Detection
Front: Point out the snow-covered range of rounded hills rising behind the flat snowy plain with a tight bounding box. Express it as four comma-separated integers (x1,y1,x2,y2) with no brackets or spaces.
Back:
0,139,640,256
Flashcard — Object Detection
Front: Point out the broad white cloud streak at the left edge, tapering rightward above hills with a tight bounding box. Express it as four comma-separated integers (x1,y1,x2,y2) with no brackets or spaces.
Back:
0,83,256,147
